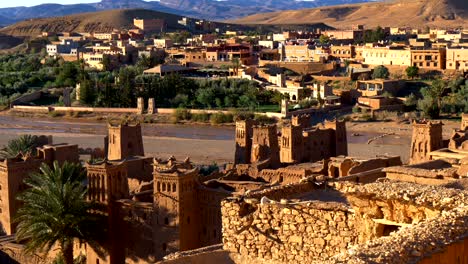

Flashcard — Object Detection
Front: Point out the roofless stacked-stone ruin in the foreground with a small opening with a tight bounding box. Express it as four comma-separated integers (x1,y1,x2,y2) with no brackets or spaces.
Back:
222,182,466,263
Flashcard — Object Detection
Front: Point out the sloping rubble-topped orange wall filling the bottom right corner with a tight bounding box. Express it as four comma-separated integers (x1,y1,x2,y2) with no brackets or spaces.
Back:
329,203,468,264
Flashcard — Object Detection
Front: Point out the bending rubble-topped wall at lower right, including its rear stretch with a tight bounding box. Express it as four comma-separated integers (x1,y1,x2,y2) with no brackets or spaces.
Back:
330,186,468,264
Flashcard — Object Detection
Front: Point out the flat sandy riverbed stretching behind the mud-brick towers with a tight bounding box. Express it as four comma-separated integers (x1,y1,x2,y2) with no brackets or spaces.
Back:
0,115,458,164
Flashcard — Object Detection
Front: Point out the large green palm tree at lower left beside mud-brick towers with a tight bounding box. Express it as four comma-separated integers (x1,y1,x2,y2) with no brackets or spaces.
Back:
16,161,106,264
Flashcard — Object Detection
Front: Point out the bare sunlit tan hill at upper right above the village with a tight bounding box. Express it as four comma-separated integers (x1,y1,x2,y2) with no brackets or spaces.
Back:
232,0,468,28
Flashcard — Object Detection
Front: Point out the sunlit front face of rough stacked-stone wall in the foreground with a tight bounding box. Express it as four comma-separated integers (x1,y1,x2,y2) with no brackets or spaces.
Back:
221,200,357,263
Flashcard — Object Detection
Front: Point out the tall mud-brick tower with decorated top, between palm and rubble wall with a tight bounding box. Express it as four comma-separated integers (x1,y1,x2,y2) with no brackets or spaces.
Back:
153,161,201,259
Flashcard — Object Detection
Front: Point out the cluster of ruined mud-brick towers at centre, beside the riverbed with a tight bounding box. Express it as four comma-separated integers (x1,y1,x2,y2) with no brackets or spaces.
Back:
235,115,348,168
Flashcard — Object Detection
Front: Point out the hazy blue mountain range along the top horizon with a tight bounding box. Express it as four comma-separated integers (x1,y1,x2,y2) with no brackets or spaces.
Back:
0,0,376,25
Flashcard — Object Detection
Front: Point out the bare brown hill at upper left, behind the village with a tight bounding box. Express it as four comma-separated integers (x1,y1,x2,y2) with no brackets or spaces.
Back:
0,9,186,37
